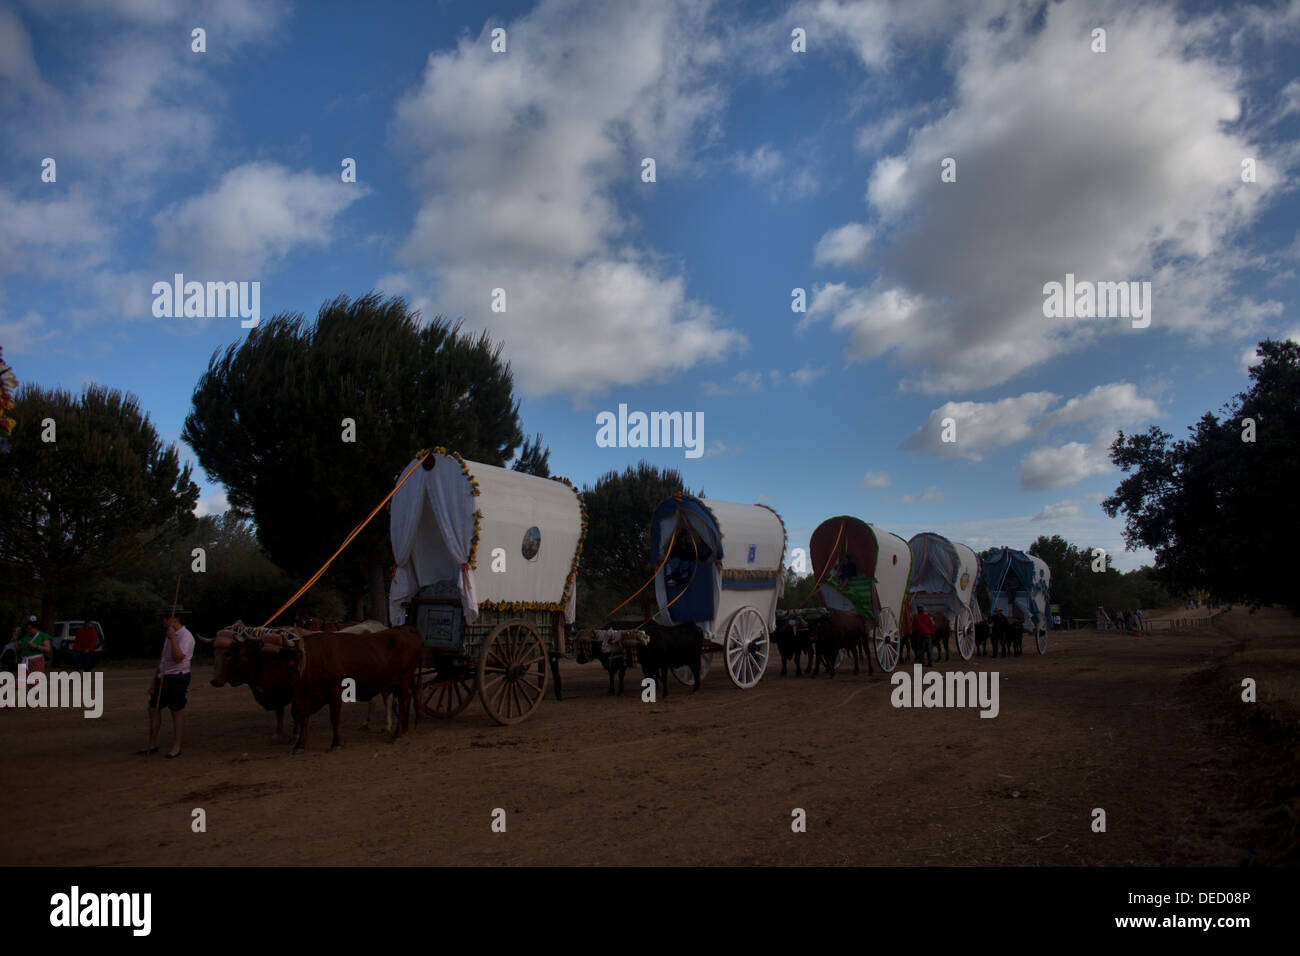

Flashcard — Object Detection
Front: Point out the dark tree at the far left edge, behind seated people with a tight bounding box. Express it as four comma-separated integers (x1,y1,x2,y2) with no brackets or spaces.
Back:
0,385,199,627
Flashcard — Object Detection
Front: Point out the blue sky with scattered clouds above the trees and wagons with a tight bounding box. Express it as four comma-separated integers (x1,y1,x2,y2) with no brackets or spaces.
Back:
0,0,1300,568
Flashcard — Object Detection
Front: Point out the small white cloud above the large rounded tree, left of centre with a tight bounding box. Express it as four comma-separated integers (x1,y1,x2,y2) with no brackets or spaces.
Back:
153,163,367,277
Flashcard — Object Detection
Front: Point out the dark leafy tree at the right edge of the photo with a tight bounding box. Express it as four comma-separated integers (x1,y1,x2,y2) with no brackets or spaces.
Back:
1102,341,1300,611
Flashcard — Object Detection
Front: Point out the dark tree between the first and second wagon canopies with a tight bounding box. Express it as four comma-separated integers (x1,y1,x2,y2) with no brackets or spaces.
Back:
577,462,702,623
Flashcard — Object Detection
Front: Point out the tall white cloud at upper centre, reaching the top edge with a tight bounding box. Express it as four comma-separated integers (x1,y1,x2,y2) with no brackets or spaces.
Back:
395,0,745,394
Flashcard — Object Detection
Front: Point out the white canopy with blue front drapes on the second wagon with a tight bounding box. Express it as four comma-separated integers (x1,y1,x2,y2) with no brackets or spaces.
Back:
650,494,785,636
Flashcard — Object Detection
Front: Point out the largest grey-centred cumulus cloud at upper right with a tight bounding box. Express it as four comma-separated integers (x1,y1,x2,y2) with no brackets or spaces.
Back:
805,3,1295,392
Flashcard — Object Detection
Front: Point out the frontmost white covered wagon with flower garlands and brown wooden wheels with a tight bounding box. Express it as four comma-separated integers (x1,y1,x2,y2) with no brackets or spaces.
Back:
389,449,586,723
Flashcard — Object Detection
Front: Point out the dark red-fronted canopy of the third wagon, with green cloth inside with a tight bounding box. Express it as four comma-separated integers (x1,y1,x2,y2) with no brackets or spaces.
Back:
809,515,911,622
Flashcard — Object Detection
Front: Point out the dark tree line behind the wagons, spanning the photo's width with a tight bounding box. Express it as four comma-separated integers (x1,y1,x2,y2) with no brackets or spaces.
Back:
0,293,1300,654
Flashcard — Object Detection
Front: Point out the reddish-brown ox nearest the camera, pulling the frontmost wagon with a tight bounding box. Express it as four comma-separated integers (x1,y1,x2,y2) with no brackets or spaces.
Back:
261,627,424,753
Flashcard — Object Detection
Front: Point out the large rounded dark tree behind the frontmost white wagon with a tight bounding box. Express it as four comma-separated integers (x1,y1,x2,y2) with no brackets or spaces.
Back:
182,293,527,619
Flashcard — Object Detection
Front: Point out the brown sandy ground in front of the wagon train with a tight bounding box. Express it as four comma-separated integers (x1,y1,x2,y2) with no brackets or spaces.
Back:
0,610,1300,865
